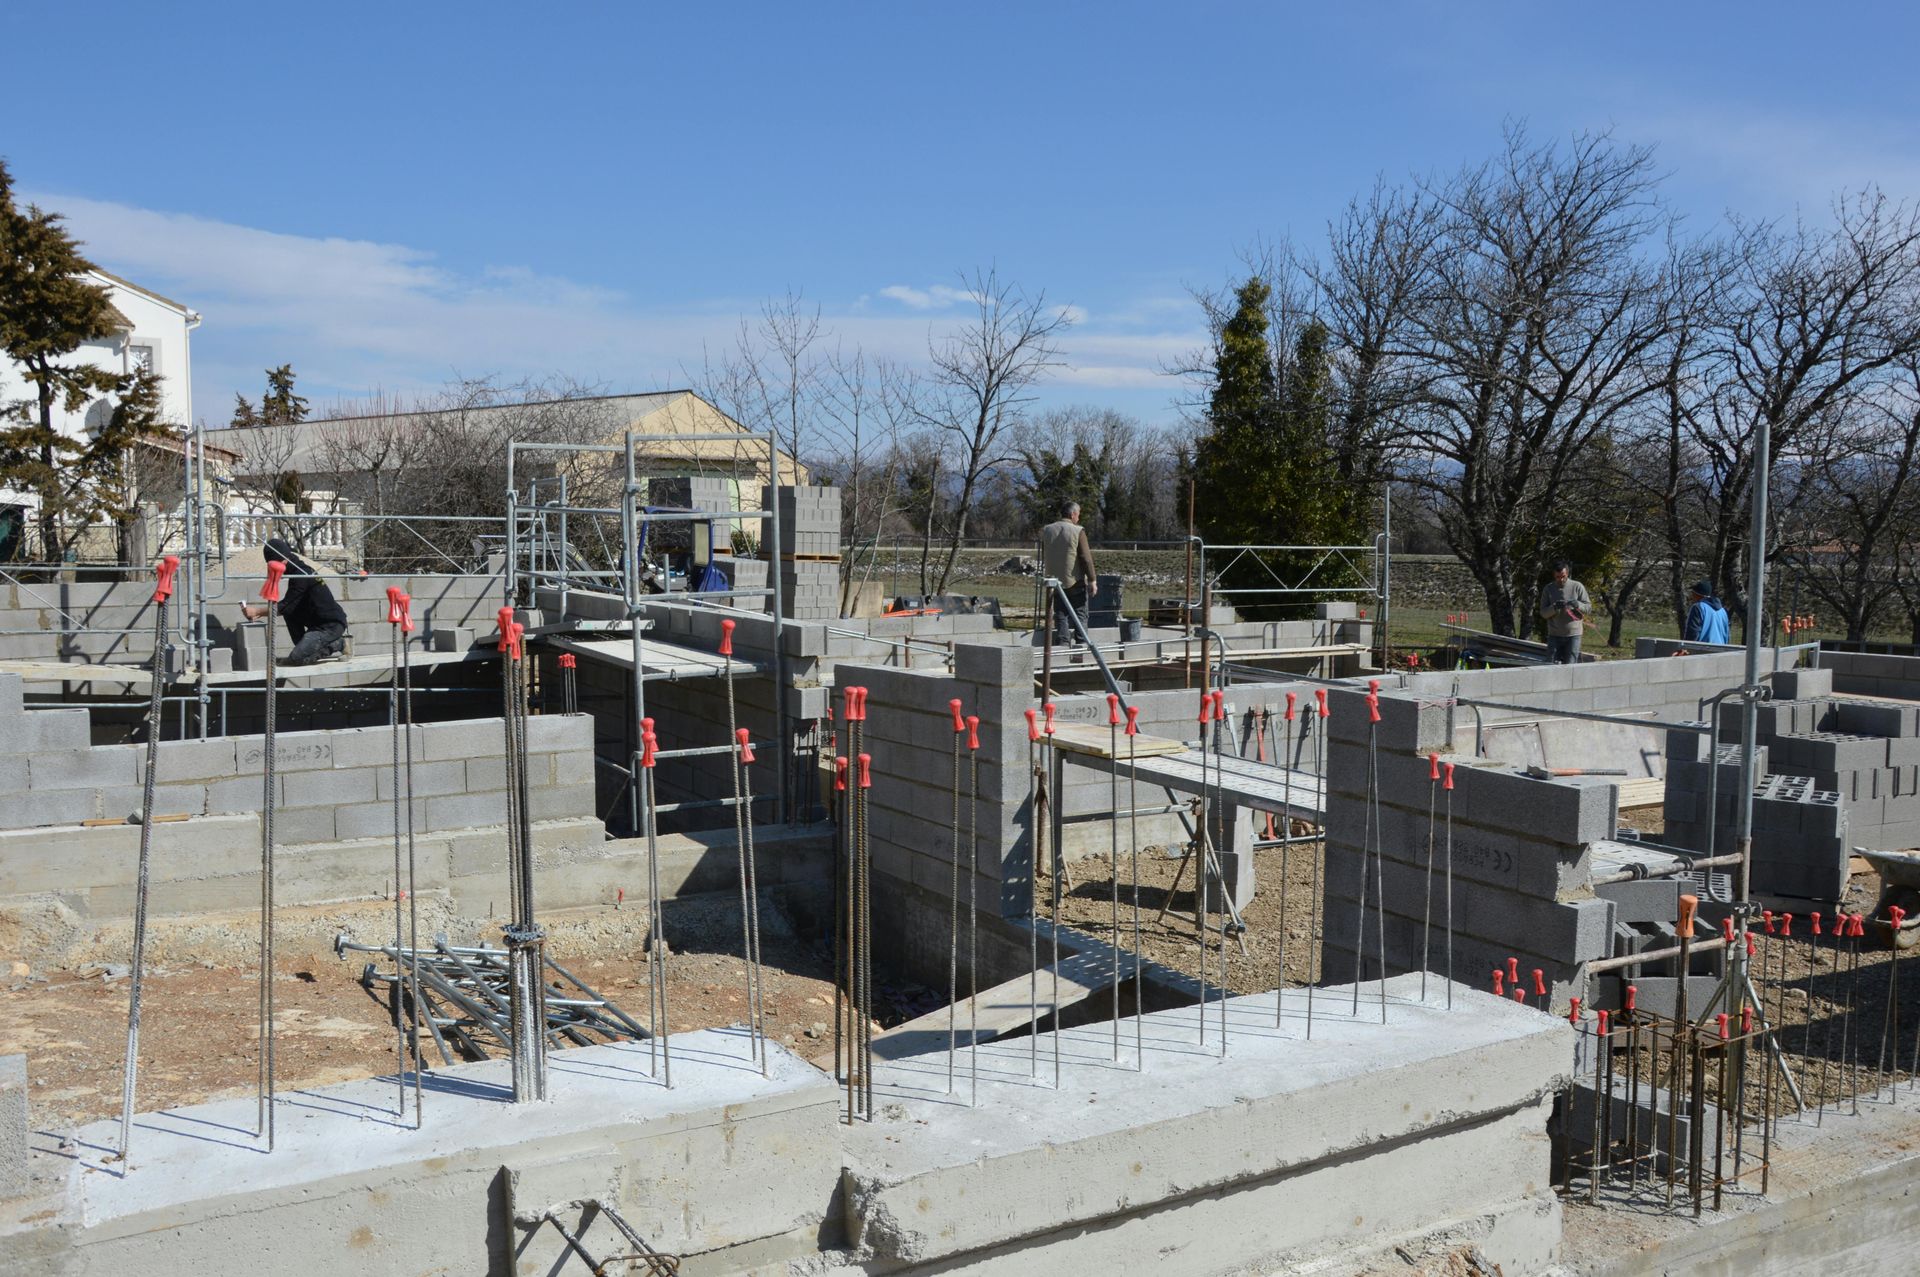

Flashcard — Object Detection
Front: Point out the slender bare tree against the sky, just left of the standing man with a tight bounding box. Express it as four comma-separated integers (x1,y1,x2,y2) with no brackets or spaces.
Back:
918,269,1073,593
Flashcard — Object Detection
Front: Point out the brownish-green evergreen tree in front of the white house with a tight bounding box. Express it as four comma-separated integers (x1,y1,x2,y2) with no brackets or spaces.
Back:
0,163,159,563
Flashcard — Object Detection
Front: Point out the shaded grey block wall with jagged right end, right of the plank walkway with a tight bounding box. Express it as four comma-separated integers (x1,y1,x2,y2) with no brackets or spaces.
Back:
1321,689,1617,1002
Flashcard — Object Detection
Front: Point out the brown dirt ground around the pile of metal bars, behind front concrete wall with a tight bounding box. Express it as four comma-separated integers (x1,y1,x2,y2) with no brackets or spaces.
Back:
0,891,935,1129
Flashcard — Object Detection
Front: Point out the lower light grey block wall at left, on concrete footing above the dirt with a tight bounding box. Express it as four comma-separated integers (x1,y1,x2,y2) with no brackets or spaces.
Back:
0,674,593,843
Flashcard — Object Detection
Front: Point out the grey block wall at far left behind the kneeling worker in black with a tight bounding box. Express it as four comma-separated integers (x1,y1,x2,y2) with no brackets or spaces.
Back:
0,566,505,668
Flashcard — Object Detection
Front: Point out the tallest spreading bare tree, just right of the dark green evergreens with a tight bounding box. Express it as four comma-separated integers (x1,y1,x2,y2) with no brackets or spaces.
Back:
1409,129,1670,634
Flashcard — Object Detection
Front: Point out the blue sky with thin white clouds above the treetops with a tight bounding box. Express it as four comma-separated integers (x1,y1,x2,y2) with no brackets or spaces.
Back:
0,2,1920,433
